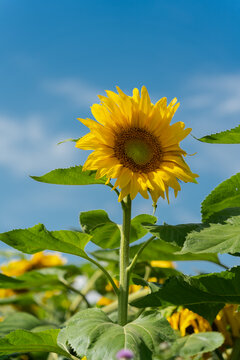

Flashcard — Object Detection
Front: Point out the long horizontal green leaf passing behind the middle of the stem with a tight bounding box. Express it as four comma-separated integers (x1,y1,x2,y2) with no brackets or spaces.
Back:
91,239,219,264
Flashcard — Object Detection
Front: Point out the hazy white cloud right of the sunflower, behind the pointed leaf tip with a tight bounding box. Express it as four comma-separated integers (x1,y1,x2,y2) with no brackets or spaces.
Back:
174,72,240,178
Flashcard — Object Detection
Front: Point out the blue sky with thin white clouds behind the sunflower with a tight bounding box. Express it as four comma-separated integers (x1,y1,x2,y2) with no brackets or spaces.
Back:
0,0,240,271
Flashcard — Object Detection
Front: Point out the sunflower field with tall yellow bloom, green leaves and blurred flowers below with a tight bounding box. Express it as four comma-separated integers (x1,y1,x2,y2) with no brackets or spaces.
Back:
0,87,240,360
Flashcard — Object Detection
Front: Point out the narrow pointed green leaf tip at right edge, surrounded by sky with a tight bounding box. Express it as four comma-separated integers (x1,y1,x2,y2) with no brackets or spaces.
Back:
197,125,240,144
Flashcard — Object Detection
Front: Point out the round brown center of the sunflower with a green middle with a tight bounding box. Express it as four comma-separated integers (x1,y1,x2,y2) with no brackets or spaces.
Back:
114,127,162,173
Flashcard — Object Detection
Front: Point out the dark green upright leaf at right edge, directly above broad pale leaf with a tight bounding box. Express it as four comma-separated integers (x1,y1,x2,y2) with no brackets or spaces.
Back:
201,173,240,222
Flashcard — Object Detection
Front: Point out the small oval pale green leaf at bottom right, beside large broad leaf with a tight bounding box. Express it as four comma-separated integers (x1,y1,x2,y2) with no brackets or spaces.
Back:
171,331,224,357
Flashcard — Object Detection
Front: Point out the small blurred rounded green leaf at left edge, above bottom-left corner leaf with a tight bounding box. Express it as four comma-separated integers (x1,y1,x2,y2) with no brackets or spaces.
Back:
0,312,44,337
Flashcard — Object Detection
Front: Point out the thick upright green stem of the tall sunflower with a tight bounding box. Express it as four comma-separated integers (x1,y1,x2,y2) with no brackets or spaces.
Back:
118,195,132,326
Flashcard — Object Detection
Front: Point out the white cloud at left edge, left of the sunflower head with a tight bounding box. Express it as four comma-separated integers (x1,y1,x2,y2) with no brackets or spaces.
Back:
0,115,77,176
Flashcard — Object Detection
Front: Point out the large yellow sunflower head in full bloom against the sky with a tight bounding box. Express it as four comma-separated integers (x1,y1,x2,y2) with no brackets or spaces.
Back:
76,86,198,203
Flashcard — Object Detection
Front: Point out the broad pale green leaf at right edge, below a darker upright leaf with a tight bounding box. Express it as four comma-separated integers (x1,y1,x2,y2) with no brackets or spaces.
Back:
180,216,240,254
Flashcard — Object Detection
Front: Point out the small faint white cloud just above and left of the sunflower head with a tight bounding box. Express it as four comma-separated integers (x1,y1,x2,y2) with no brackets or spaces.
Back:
44,78,102,107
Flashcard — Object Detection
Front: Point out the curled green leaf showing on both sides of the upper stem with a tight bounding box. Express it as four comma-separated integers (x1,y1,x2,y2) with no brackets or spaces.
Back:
80,210,157,249
